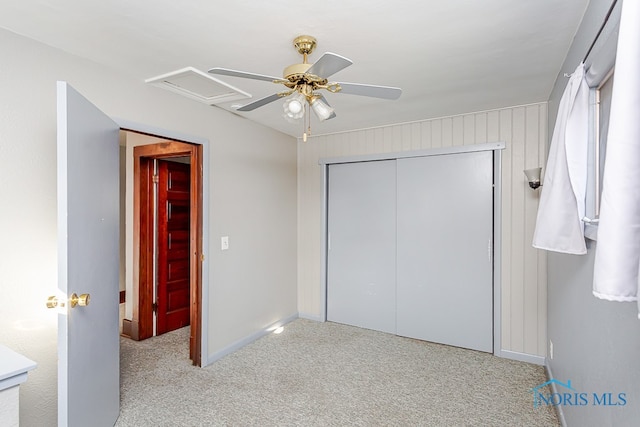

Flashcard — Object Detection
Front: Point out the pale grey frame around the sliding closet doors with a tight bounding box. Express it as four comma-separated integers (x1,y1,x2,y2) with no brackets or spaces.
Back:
318,142,506,357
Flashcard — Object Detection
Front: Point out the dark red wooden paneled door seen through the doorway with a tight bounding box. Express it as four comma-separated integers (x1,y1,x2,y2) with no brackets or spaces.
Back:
156,160,191,335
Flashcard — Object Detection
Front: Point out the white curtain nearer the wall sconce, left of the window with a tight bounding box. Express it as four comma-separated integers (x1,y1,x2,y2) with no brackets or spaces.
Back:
533,64,589,255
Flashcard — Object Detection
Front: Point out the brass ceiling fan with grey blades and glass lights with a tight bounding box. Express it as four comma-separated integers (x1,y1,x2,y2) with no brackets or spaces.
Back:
209,35,402,141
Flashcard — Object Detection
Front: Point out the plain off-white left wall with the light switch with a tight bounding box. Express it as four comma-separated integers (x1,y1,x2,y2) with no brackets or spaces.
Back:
0,30,297,426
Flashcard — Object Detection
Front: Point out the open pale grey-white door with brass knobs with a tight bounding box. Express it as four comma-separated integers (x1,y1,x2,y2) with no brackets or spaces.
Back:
57,82,120,426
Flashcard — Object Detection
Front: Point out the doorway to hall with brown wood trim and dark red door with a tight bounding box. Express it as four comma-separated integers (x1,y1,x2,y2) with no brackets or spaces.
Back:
122,131,203,366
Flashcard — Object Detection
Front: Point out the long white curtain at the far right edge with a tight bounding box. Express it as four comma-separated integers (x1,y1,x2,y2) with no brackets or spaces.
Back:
593,0,640,310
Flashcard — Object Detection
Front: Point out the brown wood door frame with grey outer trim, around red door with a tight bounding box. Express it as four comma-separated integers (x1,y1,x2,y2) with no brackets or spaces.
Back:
116,119,210,366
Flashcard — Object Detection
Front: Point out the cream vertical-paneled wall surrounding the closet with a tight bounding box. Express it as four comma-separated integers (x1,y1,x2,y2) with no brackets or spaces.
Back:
298,103,547,356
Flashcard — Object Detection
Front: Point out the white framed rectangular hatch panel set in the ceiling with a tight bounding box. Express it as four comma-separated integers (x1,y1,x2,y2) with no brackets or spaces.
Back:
145,67,251,105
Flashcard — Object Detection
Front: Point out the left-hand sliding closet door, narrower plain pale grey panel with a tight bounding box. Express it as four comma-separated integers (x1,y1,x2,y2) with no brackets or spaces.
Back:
327,160,396,333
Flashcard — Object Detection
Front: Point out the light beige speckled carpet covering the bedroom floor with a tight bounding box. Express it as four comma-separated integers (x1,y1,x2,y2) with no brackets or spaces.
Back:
116,319,559,427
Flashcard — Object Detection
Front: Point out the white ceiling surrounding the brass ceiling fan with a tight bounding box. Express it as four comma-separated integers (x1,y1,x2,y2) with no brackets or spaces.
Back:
0,0,588,136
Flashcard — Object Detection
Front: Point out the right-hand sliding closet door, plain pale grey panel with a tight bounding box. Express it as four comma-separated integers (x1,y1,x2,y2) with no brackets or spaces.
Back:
397,151,493,352
